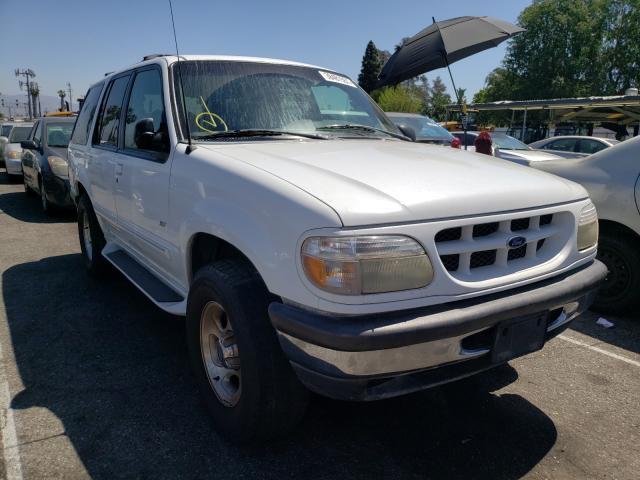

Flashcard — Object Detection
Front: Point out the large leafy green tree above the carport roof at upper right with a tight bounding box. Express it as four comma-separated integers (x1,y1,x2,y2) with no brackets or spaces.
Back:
479,0,640,101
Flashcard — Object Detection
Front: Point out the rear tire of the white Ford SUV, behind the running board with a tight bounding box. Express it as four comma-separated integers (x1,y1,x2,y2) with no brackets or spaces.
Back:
78,195,107,276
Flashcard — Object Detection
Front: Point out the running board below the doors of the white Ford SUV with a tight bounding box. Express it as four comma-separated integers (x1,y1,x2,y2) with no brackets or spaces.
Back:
103,249,185,314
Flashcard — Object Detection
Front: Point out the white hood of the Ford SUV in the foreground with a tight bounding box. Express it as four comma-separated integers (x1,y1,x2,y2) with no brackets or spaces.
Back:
203,139,587,226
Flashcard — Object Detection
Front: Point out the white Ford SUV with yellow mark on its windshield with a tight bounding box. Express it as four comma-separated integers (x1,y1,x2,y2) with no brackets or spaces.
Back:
69,56,606,441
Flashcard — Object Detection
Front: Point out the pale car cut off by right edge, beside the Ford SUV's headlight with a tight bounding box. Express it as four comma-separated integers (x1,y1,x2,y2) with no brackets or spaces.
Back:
533,138,640,317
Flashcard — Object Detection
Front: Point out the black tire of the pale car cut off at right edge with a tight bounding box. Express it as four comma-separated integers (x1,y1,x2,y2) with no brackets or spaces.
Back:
593,231,640,314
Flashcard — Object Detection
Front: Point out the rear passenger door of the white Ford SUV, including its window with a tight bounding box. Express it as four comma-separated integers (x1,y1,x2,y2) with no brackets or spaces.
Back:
87,72,131,229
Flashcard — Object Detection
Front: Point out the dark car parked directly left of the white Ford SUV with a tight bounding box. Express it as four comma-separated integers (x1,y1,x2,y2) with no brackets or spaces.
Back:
21,117,75,213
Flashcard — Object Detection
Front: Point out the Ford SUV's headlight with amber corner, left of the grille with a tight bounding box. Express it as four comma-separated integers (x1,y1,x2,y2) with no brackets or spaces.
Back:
302,235,433,295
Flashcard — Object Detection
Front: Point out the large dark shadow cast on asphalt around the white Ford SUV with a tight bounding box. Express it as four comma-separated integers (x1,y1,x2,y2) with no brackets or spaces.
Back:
3,255,557,479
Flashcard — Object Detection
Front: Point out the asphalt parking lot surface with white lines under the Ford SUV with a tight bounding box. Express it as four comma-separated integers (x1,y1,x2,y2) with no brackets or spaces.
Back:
0,170,640,480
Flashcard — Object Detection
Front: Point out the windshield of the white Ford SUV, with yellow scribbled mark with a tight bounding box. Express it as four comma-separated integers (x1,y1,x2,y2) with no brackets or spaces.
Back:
174,61,400,141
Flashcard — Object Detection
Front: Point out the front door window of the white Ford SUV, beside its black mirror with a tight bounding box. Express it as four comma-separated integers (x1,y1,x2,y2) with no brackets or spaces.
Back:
124,68,169,152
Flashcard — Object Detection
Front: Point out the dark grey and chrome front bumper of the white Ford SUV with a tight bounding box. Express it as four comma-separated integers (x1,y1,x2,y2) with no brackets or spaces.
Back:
269,260,607,400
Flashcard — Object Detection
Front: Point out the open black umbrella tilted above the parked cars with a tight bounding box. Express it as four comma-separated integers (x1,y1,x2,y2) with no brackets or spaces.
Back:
377,17,524,89
